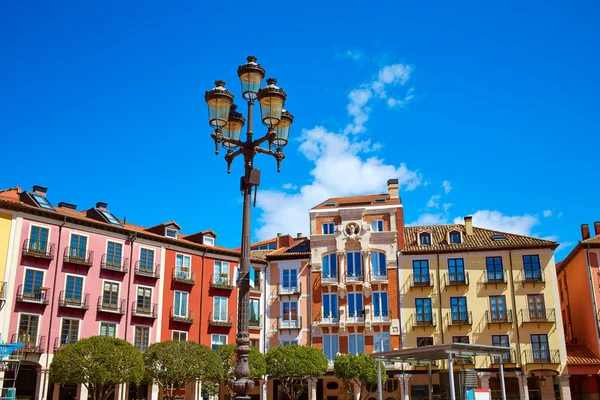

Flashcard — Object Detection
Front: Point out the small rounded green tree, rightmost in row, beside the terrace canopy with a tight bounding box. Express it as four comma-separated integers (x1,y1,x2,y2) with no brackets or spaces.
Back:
333,353,385,400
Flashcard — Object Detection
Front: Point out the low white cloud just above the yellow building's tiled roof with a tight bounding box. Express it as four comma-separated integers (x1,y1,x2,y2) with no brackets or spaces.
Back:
454,210,540,236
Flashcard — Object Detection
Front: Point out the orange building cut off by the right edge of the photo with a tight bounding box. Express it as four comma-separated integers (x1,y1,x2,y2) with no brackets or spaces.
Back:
556,222,600,400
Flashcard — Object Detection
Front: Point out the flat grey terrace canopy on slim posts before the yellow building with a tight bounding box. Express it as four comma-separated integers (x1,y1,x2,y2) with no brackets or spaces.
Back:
371,343,511,400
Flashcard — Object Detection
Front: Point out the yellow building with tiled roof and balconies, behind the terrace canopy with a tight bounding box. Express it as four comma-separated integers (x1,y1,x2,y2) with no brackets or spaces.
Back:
399,217,570,400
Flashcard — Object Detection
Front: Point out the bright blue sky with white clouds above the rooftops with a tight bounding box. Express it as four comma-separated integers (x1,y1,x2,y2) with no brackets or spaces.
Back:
0,1,600,259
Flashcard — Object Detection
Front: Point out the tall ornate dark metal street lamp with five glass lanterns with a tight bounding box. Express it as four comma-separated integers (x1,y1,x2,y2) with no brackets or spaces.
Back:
204,56,294,400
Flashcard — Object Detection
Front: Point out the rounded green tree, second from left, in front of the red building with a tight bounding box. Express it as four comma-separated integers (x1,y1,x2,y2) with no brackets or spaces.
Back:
144,340,221,399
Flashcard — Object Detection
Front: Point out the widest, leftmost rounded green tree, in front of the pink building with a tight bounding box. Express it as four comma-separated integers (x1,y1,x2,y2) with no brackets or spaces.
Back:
50,336,144,400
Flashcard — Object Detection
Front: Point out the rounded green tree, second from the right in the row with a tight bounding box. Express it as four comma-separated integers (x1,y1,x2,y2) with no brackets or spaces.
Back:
266,344,328,400
